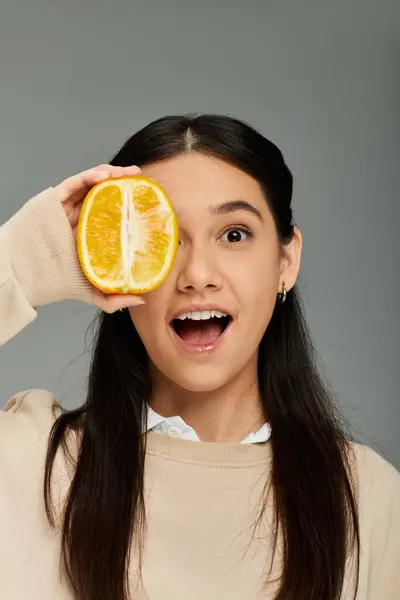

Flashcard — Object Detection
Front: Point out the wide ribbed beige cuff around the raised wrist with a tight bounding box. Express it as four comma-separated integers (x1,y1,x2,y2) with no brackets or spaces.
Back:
4,188,93,308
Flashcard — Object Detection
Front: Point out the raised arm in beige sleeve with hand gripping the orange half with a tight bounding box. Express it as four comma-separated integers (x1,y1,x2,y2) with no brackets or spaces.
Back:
0,165,147,345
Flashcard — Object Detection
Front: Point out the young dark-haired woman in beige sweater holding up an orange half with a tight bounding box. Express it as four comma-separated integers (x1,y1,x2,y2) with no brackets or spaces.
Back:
0,115,400,600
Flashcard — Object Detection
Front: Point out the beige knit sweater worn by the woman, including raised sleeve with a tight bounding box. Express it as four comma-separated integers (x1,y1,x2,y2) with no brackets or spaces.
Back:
0,190,400,600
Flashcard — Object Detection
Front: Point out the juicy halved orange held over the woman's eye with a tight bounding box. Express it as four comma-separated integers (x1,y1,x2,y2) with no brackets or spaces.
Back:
77,176,179,294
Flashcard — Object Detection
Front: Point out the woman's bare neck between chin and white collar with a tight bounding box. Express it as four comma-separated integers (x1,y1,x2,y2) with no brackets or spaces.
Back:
149,359,266,443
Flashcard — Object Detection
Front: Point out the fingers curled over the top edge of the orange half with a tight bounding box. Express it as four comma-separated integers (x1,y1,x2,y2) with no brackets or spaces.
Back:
56,165,141,202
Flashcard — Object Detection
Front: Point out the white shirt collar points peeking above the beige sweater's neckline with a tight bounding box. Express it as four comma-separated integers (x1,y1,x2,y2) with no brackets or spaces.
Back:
147,406,271,444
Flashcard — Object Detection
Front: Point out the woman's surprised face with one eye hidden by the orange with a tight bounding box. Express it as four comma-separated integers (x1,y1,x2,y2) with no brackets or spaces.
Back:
130,152,301,392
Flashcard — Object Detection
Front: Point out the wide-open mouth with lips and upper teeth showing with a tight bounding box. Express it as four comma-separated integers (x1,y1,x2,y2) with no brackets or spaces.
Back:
171,310,232,346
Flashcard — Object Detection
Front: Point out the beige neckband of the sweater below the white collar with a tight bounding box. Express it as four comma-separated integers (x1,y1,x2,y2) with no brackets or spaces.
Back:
145,431,272,468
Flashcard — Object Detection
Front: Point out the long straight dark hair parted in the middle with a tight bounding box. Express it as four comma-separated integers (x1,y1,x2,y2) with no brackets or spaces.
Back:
44,115,360,600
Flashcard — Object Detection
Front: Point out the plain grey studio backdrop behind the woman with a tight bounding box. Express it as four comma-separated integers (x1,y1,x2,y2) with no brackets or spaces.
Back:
0,0,400,467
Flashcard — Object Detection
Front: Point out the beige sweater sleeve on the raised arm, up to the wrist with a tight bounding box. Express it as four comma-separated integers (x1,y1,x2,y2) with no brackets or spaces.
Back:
0,188,92,345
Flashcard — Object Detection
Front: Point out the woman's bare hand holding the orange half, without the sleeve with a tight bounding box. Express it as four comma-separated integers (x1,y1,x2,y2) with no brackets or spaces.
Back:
54,165,144,313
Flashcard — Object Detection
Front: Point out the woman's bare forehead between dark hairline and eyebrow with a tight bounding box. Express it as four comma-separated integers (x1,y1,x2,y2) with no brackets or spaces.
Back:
142,152,267,214
